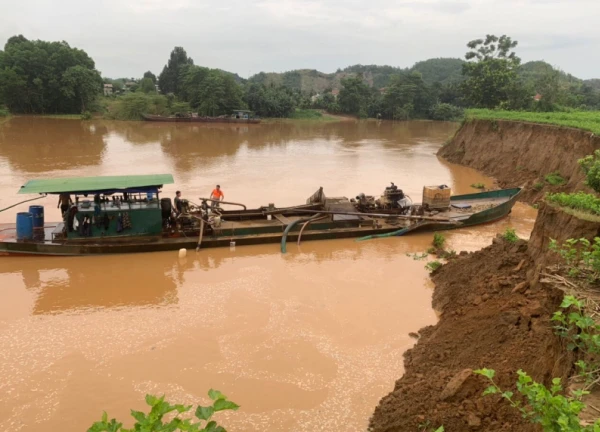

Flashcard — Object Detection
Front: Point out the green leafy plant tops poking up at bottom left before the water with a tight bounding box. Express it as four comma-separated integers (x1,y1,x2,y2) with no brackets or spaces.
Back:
88,389,239,432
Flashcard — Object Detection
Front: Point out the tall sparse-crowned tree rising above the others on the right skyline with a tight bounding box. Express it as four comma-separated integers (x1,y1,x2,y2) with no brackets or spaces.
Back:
463,35,521,108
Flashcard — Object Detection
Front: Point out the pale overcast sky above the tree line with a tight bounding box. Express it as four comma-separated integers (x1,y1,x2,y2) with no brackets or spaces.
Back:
0,0,600,78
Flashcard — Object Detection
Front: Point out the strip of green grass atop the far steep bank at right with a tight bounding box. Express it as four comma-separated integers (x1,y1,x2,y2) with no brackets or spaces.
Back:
466,109,600,134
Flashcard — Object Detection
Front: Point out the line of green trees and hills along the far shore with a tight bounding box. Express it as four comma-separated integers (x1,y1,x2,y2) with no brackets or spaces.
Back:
0,35,600,120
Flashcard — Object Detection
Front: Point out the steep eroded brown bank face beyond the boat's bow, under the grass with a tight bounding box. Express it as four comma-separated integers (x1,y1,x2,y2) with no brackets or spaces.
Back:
438,120,600,202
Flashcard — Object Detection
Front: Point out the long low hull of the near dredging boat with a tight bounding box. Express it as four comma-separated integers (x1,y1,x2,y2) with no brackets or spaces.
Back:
0,188,521,256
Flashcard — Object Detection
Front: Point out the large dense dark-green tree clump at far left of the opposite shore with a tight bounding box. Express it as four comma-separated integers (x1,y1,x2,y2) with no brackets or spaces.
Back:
0,35,102,114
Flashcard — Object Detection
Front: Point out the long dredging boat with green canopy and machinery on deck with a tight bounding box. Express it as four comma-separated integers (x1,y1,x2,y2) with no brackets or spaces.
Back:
0,174,521,256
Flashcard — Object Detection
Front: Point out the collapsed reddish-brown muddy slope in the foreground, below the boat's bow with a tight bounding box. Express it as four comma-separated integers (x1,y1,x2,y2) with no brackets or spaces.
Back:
370,238,573,432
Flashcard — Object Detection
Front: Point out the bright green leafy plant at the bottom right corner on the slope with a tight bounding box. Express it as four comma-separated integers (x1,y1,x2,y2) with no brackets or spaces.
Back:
473,368,600,432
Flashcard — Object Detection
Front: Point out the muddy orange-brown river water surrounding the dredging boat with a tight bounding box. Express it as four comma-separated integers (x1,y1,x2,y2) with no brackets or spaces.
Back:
0,118,535,432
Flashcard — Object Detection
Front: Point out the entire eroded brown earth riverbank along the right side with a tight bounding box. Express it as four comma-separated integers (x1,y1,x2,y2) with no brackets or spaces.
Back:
370,119,600,432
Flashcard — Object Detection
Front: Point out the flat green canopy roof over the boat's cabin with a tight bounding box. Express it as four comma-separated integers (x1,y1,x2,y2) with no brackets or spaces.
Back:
19,174,174,194
